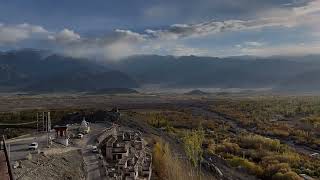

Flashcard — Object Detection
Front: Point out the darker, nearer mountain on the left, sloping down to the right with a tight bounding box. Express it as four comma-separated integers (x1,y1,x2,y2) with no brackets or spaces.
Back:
0,50,138,91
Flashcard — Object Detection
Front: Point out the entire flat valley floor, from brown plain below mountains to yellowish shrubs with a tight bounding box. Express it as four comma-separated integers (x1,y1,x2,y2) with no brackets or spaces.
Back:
0,94,320,180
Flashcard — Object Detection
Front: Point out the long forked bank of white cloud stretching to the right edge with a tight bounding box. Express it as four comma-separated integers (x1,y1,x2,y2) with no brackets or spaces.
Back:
44,2,320,60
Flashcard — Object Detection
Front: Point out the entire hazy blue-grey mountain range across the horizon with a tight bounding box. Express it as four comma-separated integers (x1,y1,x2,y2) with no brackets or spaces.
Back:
0,49,320,92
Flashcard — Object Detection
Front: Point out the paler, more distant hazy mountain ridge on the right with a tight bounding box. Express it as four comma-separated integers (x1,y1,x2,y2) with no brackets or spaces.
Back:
113,55,320,88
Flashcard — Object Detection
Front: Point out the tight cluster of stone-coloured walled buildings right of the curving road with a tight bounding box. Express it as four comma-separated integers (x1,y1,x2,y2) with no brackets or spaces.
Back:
99,127,152,180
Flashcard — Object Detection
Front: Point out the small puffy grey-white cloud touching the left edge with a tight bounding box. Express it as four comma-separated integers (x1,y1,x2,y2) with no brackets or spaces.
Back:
0,23,49,44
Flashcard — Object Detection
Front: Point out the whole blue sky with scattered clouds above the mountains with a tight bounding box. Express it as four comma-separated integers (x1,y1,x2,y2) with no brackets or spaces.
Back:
0,0,320,59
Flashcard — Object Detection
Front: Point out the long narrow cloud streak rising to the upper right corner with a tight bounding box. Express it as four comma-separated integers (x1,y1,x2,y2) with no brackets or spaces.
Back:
142,1,320,40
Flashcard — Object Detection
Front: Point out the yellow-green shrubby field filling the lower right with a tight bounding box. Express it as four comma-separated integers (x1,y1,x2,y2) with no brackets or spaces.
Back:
122,97,320,179
